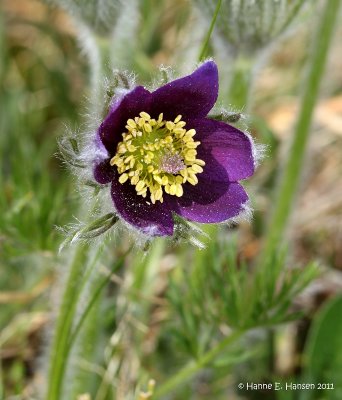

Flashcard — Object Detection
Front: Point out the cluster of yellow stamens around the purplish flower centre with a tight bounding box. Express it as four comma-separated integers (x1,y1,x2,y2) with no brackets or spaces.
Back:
110,112,205,204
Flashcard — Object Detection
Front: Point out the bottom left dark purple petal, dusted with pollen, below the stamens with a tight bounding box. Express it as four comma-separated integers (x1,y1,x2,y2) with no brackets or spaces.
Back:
112,172,173,236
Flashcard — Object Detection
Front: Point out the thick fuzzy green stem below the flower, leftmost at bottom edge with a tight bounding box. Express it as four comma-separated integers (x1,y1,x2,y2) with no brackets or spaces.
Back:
46,243,89,400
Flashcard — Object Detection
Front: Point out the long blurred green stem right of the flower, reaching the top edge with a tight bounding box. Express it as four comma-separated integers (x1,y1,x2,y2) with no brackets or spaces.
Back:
261,0,341,260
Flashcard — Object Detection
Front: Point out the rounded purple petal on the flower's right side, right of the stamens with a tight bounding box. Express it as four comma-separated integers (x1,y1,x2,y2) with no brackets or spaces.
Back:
187,118,255,182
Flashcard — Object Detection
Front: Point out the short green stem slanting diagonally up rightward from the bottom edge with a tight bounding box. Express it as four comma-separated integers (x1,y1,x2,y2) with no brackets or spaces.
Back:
153,331,244,400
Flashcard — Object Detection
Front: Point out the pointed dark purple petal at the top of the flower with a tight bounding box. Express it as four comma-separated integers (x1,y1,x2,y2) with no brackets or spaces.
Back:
151,61,218,120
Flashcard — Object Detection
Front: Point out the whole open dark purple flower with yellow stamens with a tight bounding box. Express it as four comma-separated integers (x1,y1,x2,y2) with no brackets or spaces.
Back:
93,61,254,236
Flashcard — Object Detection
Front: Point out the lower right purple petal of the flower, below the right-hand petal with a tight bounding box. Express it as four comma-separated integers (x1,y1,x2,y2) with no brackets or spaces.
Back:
175,180,248,223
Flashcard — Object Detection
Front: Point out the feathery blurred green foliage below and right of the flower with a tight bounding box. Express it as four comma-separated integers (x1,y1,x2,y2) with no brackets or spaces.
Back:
168,238,318,357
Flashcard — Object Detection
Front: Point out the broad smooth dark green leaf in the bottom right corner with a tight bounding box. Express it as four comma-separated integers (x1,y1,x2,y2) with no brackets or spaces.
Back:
299,295,342,400
